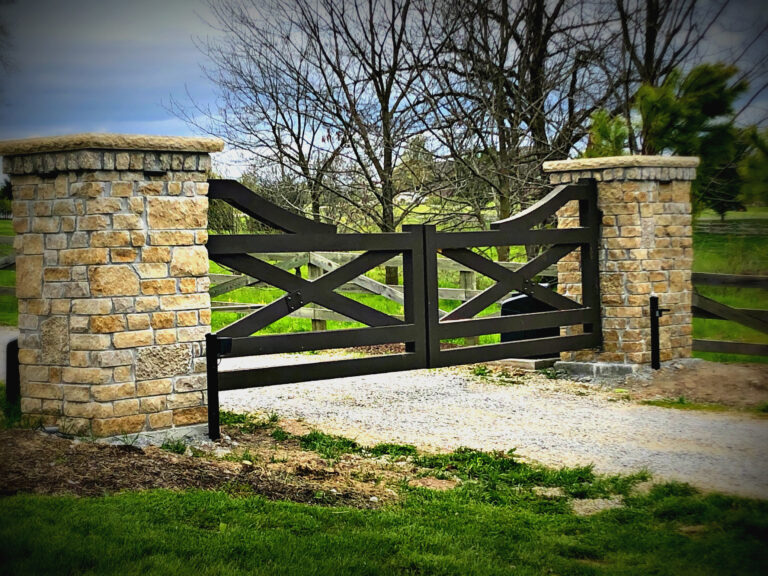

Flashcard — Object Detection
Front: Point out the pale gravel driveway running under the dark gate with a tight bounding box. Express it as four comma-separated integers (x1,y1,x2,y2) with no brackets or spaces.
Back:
221,355,768,498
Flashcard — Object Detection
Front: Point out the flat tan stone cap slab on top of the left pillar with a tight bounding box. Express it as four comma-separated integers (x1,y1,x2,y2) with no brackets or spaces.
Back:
0,132,224,156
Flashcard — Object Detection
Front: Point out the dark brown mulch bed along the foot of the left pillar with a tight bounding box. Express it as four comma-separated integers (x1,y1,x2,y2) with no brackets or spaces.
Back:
0,429,379,508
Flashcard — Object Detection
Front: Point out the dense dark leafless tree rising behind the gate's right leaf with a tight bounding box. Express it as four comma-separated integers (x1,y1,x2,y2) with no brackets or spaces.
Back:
420,0,615,259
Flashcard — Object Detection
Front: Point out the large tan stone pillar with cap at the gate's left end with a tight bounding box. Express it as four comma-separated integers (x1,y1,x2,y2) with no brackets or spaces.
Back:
0,134,222,436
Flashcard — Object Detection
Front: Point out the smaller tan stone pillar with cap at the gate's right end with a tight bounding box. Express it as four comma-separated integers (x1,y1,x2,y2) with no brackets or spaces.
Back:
544,156,699,367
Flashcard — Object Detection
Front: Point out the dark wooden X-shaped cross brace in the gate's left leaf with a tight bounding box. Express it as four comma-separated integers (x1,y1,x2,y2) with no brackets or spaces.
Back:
216,250,403,338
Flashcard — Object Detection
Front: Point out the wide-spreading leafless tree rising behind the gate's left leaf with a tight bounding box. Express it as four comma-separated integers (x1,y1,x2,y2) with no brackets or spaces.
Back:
176,0,444,281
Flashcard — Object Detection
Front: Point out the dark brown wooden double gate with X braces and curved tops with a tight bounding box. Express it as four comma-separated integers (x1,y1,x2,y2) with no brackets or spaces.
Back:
206,180,602,438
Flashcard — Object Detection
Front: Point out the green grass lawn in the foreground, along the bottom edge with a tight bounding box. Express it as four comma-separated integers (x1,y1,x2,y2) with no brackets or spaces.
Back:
0,444,768,576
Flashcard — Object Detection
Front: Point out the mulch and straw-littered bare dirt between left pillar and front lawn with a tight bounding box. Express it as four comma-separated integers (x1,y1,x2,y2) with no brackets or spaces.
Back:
0,422,448,508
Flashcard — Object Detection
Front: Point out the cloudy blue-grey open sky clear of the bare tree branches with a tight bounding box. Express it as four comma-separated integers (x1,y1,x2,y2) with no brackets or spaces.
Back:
0,0,768,173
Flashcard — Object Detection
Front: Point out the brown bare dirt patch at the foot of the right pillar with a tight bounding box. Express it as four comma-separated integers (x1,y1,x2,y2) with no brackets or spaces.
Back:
623,360,768,408
